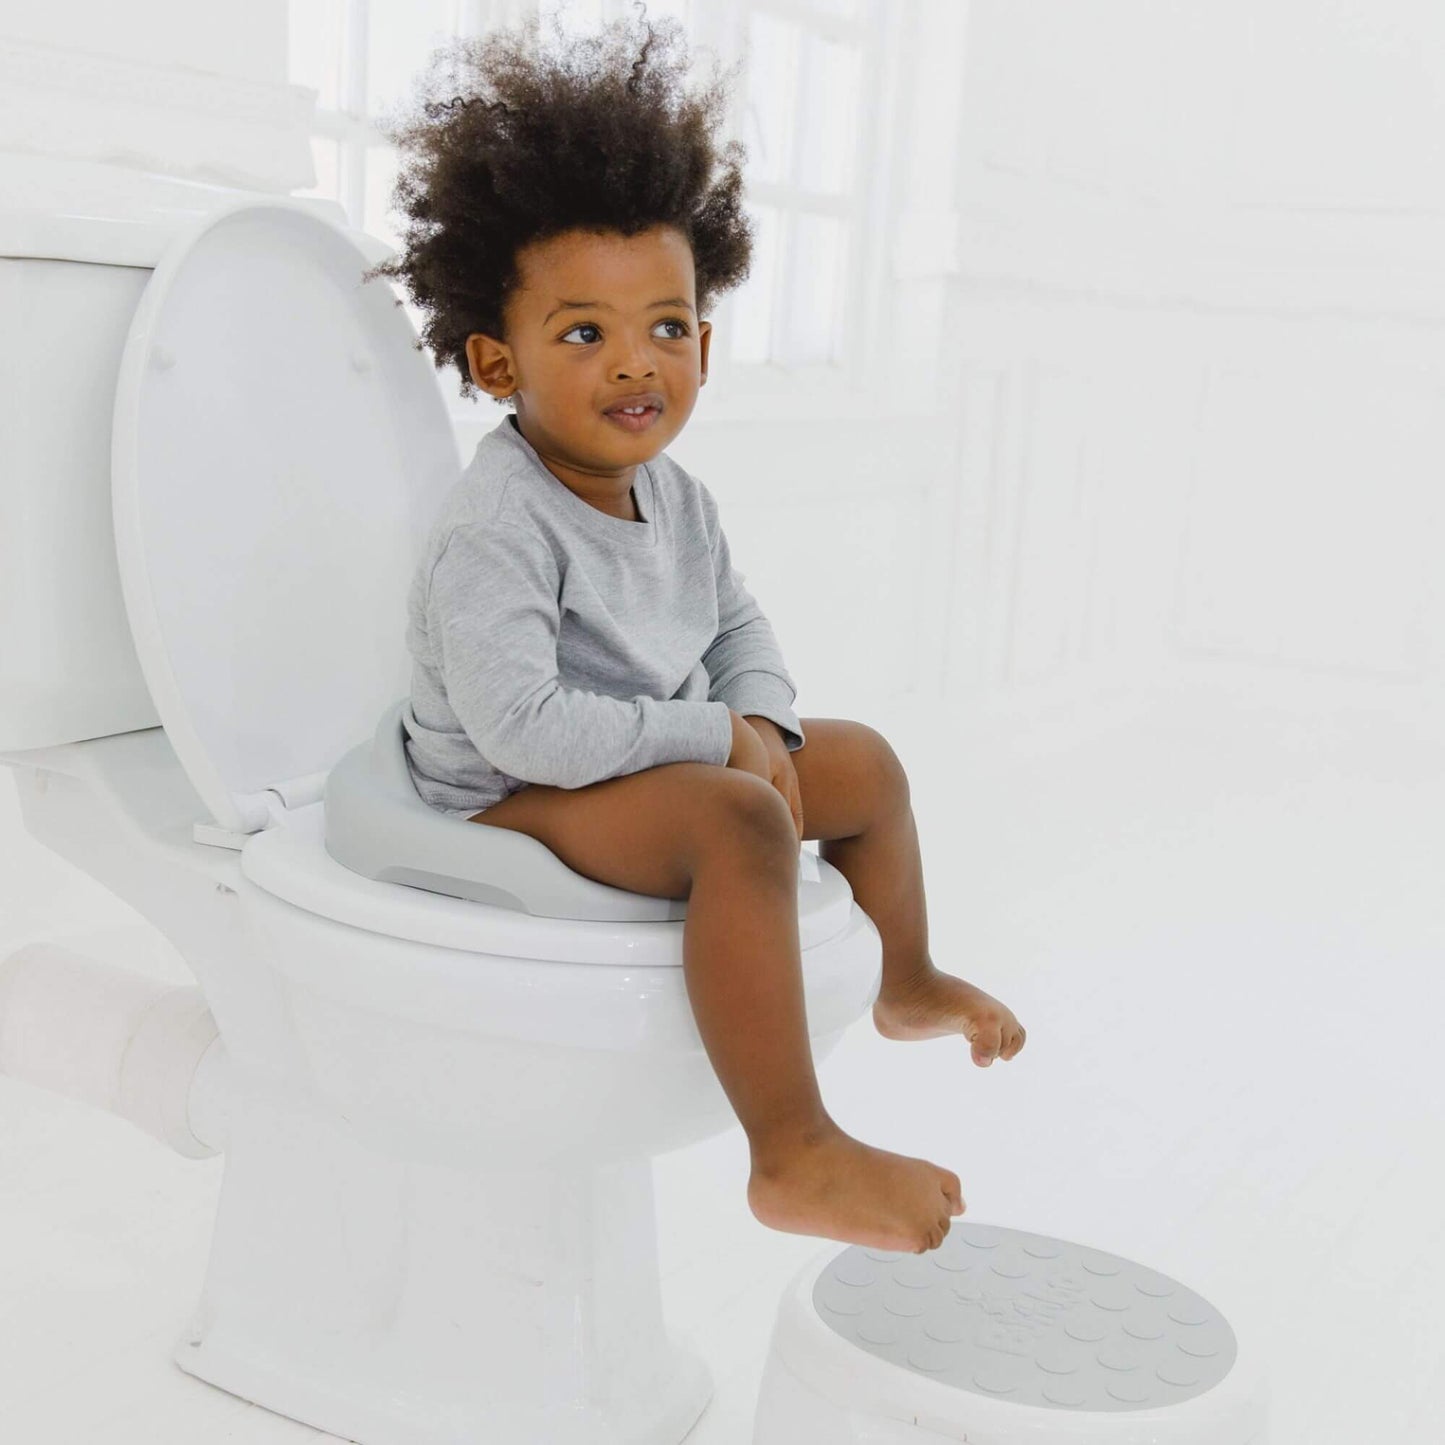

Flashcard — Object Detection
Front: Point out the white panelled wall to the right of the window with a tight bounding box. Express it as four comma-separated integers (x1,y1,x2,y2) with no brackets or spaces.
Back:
945,0,1445,728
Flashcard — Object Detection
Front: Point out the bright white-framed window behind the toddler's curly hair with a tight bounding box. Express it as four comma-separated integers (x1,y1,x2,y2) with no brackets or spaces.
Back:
289,0,900,409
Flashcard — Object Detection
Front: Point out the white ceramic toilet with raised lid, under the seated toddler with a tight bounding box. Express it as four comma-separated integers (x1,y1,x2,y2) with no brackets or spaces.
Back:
0,183,881,1445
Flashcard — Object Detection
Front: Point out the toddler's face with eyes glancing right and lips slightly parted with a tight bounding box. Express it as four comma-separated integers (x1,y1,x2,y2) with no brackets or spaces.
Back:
467,225,712,475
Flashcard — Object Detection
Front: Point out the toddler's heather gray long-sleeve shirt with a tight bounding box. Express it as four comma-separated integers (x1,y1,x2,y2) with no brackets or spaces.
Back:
403,415,805,814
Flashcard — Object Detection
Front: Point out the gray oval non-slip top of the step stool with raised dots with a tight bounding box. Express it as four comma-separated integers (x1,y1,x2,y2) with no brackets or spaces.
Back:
812,1222,1238,1410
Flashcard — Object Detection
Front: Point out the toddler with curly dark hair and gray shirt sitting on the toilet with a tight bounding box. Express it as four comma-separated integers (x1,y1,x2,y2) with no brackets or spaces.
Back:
368,8,1025,1253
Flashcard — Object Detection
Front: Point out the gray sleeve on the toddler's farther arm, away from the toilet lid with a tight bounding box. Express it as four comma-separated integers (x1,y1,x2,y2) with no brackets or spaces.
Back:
698,481,806,753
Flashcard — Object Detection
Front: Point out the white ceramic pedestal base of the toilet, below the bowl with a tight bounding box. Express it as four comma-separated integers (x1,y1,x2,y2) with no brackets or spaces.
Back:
175,1079,712,1445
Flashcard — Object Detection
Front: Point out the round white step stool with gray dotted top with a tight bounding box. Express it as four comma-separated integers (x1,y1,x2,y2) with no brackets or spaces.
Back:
753,1220,1269,1445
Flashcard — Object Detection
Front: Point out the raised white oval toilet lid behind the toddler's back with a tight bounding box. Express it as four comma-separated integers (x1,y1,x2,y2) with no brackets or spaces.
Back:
111,199,461,832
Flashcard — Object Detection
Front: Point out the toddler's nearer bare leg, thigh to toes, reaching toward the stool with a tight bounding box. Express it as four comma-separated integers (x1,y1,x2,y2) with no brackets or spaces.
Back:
475,763,962,1253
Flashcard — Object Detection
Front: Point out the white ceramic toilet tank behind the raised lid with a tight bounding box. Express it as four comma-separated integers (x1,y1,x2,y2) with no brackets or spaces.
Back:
0,167,390,753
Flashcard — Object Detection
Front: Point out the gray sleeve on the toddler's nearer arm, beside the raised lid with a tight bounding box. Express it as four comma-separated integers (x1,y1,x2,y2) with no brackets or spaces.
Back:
426,522,733,788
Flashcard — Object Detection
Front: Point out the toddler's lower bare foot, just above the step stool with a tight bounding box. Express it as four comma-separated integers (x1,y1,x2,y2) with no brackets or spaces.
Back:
747,1127,964,1254
